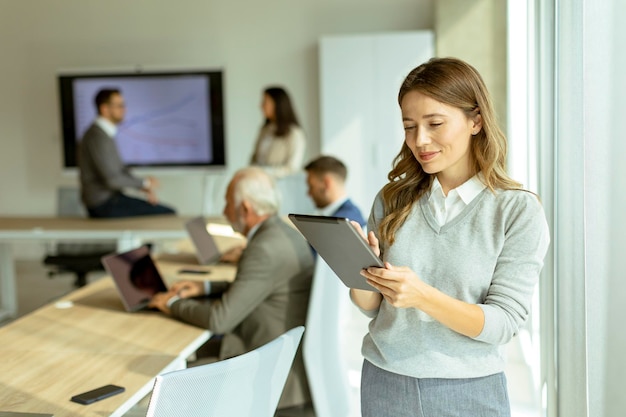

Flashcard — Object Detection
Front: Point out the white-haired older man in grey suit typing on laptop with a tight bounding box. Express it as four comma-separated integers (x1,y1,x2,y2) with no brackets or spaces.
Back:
150,167,313,408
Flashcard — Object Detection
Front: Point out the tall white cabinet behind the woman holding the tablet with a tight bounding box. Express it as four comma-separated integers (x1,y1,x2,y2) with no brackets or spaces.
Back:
319,31,434,214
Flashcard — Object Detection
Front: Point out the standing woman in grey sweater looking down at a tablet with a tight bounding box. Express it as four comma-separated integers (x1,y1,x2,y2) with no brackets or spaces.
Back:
350,58,549,417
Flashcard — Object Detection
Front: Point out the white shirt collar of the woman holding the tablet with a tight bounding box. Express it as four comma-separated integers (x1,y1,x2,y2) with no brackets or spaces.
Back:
428,174,487,226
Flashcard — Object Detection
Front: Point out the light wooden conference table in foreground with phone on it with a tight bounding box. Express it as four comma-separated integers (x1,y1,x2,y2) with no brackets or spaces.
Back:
0,261,235,417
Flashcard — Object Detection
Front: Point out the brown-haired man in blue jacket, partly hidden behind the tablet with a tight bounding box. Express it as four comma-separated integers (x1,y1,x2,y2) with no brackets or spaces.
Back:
304,156,367,227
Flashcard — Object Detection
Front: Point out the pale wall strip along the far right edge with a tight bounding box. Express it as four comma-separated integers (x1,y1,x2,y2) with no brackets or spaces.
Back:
580,0,626,417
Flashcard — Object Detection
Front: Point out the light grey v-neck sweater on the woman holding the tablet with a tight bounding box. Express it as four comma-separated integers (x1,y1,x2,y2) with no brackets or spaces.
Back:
362,189,549,378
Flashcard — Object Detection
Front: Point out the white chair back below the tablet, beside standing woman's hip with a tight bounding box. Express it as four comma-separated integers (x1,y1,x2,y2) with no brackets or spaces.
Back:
302,256,351,417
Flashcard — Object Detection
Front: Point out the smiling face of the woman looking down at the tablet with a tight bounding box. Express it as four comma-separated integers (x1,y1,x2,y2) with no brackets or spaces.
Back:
400,90,482,192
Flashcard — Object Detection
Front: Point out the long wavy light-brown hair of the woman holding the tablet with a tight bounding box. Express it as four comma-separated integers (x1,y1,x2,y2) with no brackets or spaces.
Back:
378,58,521,245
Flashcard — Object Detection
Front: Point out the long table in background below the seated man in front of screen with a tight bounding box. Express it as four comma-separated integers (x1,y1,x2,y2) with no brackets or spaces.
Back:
0,215,224,321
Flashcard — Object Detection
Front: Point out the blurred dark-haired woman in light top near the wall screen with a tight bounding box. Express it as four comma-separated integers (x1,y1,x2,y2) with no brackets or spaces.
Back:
250,87,306,177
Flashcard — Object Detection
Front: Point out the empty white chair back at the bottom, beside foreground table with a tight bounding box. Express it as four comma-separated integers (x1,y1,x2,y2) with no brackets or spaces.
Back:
146,326,304,417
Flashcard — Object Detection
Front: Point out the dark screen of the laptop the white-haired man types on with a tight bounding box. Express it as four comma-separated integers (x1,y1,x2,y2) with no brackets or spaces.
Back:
102,246,167,312
